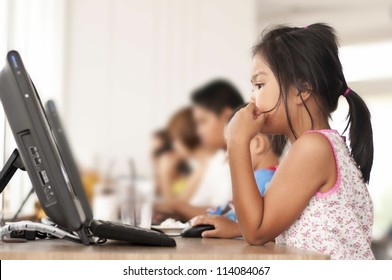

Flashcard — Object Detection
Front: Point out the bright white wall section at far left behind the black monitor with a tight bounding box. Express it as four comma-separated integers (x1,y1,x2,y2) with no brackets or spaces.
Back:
0,0,64,216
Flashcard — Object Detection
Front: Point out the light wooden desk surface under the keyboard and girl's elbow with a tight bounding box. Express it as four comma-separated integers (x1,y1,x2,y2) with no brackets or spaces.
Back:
0,237,329,260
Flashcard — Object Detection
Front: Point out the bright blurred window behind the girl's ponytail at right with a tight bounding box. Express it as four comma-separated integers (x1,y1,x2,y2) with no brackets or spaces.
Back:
332,41,392,238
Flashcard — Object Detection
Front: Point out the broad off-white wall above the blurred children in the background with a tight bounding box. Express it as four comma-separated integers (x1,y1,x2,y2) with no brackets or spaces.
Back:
63,0,257,174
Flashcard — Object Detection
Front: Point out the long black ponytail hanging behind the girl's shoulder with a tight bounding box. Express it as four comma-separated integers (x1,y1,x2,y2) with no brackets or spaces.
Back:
344,88,374,183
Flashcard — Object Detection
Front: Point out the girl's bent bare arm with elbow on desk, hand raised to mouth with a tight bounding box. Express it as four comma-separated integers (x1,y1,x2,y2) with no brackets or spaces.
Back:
228,104,336,244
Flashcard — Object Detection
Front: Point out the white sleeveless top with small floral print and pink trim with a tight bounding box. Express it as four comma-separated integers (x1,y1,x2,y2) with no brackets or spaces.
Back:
276,130,374,259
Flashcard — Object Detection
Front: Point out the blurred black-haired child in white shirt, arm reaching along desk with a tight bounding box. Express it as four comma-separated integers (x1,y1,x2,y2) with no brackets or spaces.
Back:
152,80,243,221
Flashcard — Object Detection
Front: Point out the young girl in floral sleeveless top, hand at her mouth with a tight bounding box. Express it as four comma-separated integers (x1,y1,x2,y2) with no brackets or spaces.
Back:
228,24,374,259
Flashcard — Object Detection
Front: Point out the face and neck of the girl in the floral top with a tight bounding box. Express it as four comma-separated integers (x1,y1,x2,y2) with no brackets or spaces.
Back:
251,55,291,134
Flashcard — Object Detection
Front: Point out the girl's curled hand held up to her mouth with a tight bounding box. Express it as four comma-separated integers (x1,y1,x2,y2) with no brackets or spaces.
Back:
227,102,266,144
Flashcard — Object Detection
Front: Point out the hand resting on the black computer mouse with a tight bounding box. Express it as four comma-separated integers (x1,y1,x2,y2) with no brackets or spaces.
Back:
192,215,242,238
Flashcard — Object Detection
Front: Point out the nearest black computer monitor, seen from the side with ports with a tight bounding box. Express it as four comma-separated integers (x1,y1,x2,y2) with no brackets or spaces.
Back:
0,51,91,245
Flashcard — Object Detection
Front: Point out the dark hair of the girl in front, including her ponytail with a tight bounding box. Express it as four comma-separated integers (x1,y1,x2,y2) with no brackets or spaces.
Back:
253,23,373,182
